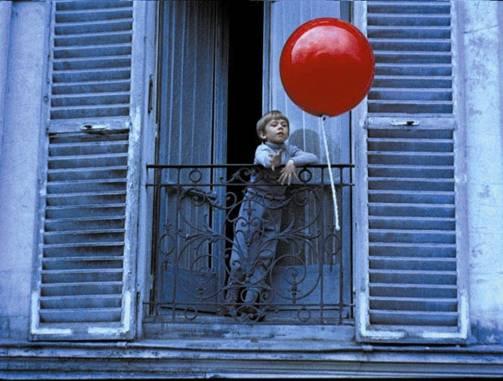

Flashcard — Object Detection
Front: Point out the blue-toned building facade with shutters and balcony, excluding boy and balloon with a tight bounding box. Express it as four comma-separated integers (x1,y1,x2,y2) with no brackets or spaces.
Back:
0,0,503,378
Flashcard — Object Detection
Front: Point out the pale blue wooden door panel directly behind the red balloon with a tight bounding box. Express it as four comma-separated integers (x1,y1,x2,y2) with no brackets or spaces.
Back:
264,0,352,314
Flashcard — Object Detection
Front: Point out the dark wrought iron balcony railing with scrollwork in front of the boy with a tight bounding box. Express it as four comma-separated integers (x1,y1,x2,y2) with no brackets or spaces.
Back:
145,164,353,324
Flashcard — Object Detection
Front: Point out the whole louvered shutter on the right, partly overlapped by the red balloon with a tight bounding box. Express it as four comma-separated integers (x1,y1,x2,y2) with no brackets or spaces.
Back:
356,0,468,343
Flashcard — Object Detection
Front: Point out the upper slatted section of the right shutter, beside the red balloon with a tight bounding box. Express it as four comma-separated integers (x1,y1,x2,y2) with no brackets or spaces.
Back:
367,1,453,115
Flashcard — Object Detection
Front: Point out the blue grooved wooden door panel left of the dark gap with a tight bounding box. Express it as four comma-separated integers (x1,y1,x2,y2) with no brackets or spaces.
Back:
156,1,227,309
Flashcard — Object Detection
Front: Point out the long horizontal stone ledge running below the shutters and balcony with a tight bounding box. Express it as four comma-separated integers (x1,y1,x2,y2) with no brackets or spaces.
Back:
0,339,503,379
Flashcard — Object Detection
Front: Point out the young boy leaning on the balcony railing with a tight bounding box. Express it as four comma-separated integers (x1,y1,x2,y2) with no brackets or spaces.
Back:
225,110,318,316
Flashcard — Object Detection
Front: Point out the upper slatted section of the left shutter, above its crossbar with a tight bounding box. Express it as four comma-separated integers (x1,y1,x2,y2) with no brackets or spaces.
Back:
50,1,133,121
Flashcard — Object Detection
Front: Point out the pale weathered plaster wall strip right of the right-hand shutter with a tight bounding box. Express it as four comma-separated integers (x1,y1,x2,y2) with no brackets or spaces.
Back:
459,0,503,343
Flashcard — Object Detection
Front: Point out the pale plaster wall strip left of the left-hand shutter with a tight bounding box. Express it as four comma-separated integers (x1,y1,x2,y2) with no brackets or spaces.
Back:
0,2,49,339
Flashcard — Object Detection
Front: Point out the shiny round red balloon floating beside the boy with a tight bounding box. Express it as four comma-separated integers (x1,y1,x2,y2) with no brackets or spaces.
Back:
280,17,375,116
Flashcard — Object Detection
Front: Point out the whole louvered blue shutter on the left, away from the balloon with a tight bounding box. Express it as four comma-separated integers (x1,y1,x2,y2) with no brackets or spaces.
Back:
31,0,140,340
